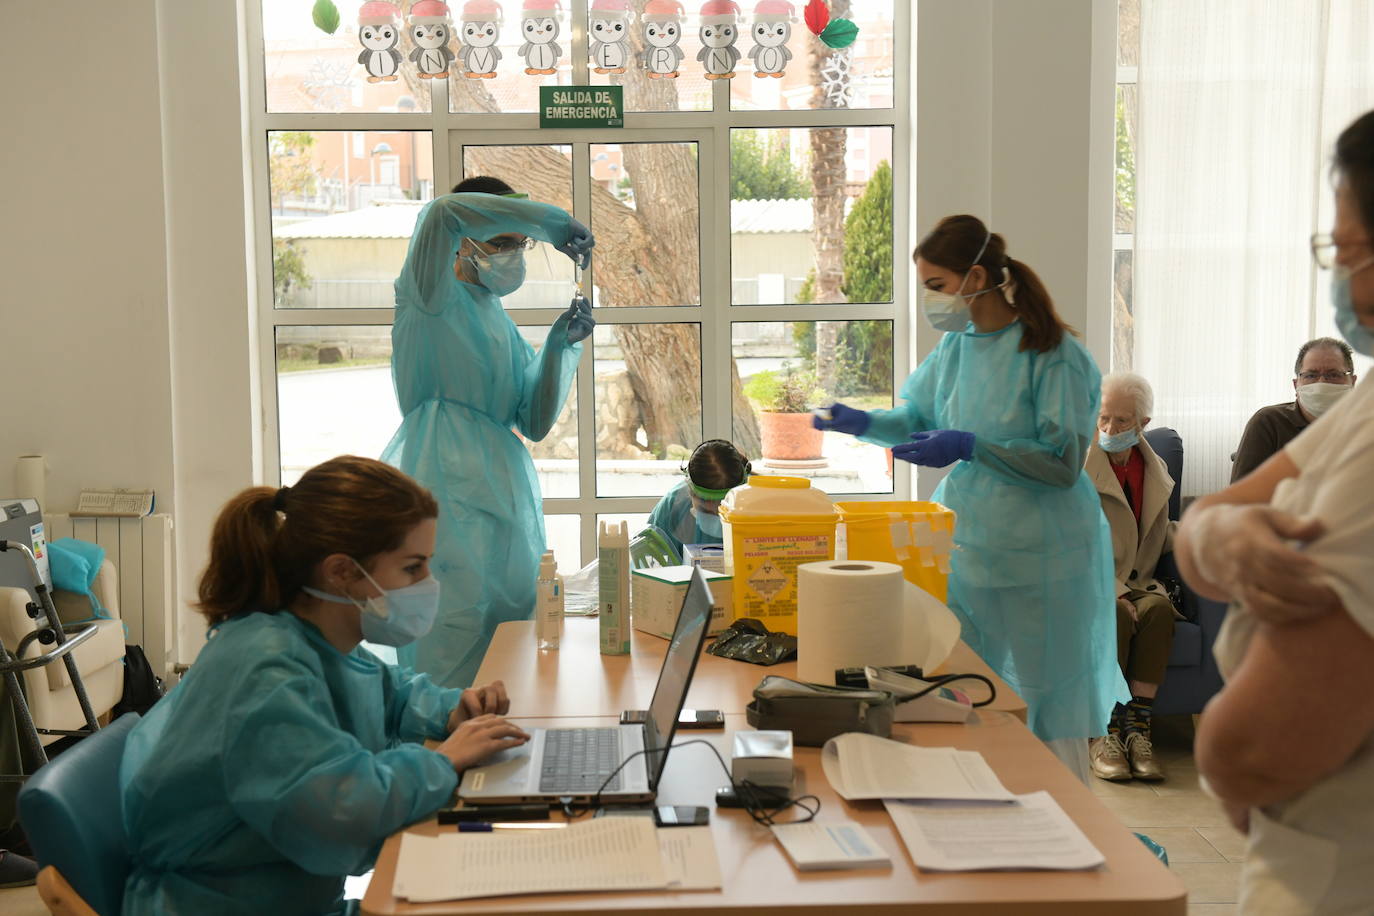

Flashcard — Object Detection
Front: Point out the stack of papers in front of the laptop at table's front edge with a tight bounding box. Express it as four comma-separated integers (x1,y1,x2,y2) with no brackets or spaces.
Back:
393,817,720,902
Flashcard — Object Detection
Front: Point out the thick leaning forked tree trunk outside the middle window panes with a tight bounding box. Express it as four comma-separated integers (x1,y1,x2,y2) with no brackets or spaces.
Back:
448,0,761,457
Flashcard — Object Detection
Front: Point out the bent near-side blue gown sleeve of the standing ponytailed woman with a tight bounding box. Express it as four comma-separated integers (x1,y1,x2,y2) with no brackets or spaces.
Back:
973,353,1102,489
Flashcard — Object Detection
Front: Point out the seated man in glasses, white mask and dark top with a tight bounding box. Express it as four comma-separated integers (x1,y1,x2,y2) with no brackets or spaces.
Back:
1231,336,1355,483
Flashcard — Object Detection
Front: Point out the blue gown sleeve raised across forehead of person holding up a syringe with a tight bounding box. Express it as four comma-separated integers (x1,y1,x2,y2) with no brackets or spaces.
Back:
396,194,573,314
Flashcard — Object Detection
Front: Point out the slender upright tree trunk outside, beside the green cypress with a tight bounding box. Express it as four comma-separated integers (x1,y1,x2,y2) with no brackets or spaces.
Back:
811,0,849,393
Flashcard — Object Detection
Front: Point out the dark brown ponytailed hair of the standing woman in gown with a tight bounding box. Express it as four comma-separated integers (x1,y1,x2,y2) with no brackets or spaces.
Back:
911,214,1077,353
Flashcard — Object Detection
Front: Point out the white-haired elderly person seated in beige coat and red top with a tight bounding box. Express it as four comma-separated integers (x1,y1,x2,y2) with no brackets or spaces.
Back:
1087,372,1178,780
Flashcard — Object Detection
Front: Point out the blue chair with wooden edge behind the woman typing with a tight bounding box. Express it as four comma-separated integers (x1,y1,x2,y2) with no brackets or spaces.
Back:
19,713,139,916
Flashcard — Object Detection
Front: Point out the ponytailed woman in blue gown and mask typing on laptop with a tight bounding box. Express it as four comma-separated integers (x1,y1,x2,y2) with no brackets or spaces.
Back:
120,457,528,916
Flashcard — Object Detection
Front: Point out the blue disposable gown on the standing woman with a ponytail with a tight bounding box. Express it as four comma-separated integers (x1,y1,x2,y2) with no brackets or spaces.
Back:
863,321,1129,742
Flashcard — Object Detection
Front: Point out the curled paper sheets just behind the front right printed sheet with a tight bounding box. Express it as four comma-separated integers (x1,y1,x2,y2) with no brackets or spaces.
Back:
820,732,1014,802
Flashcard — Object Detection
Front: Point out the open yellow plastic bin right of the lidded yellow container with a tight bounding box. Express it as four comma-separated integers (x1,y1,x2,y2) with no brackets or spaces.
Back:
835,501,955,602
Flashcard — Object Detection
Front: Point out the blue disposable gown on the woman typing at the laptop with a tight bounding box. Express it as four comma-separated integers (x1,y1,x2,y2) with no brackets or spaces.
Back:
120,611,462,916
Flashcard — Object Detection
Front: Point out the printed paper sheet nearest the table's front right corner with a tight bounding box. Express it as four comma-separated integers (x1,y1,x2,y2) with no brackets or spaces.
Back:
883,792,1106,872
